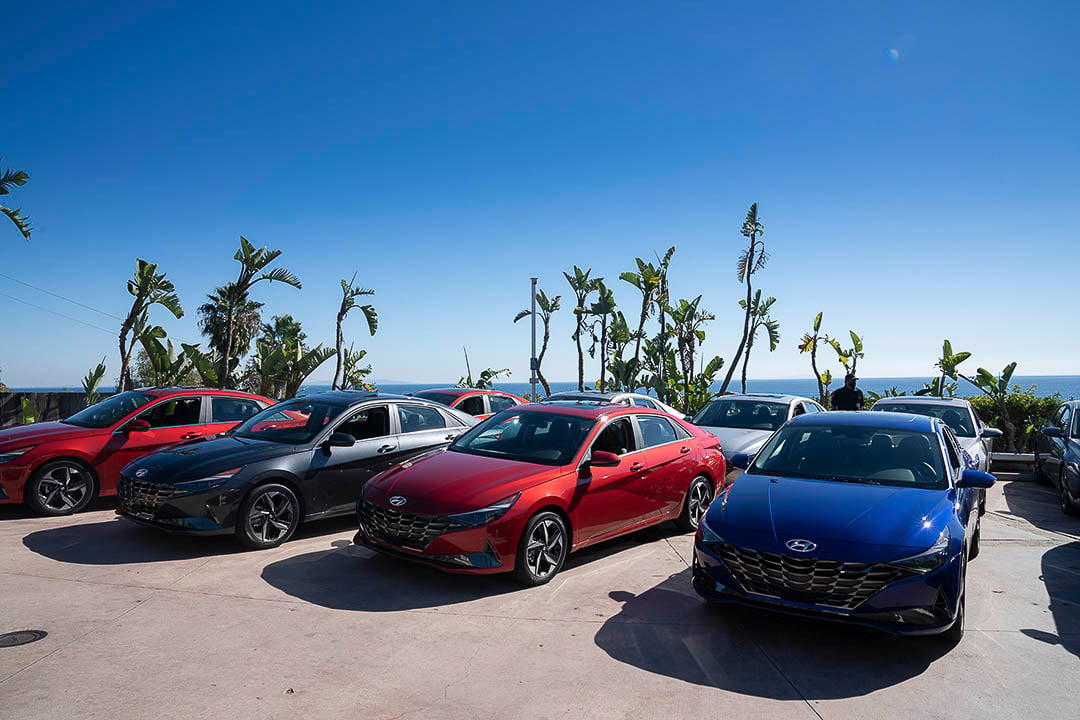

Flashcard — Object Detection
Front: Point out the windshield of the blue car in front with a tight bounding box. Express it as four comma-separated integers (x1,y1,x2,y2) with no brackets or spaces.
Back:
746,424,948,489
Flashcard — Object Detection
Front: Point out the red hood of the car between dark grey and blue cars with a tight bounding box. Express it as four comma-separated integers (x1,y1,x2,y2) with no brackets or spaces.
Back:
364,450,571,515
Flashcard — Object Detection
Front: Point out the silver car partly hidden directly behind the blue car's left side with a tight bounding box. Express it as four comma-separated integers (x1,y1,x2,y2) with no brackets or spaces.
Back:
692,393,825,459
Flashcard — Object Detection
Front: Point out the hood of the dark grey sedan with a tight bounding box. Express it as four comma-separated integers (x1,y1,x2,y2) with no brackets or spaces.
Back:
123,436,298,483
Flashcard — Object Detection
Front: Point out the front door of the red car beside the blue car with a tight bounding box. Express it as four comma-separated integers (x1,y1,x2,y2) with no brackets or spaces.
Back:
570,416,649,543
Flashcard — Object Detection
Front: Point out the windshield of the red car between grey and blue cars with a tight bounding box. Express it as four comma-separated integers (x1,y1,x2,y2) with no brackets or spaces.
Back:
450,410,596,465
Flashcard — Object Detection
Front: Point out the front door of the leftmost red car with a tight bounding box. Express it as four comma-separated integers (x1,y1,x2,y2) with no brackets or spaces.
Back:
94,395,210,493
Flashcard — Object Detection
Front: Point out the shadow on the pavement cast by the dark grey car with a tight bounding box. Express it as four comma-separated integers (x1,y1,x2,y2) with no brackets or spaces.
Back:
23,517,355,565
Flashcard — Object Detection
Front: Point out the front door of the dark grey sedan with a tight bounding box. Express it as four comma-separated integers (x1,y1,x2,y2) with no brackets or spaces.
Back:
308,404,397,515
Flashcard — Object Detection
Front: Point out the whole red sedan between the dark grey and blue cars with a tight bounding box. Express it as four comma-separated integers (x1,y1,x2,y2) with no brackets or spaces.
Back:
354,403,726,585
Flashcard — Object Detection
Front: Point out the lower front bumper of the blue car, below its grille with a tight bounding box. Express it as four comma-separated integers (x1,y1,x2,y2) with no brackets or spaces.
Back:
692,539,960,635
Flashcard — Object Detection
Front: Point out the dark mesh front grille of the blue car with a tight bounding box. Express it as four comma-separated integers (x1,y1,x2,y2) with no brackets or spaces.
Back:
712,543,914,610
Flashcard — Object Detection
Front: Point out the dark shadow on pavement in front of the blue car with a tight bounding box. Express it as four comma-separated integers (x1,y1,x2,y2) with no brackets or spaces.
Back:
595,569,948,701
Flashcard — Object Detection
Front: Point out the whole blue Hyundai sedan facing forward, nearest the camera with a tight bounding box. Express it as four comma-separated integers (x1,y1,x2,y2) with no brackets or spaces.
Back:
692,412,994,641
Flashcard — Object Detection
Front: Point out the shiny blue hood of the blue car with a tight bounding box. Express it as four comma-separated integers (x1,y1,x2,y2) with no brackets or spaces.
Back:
706,474,953,557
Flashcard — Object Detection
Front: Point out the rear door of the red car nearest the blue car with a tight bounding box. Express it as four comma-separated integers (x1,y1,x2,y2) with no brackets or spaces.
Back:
634,415,700,517
